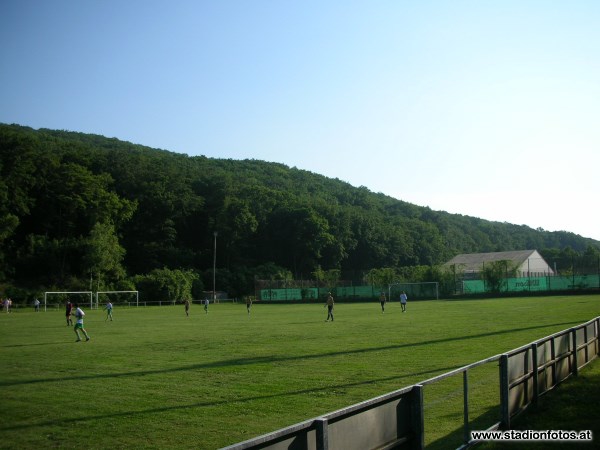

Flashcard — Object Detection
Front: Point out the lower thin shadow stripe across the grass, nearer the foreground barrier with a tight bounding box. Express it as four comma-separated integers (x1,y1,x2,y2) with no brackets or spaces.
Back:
0,366,458,431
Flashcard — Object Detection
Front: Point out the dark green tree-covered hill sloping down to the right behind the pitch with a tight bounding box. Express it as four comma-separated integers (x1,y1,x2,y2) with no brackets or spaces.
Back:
0,125,600,298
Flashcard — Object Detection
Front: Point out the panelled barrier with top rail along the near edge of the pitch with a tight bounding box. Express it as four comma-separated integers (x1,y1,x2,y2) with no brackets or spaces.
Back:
222,316,600,450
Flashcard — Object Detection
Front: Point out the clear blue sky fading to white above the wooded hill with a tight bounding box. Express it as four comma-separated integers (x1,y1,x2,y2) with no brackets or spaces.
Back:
0,0,600,240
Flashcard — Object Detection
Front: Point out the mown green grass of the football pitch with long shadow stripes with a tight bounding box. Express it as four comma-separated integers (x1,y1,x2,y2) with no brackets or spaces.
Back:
0,295,600,449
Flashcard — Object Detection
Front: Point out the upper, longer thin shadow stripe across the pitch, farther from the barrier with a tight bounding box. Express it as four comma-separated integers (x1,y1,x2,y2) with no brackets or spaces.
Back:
0,322,579,387
